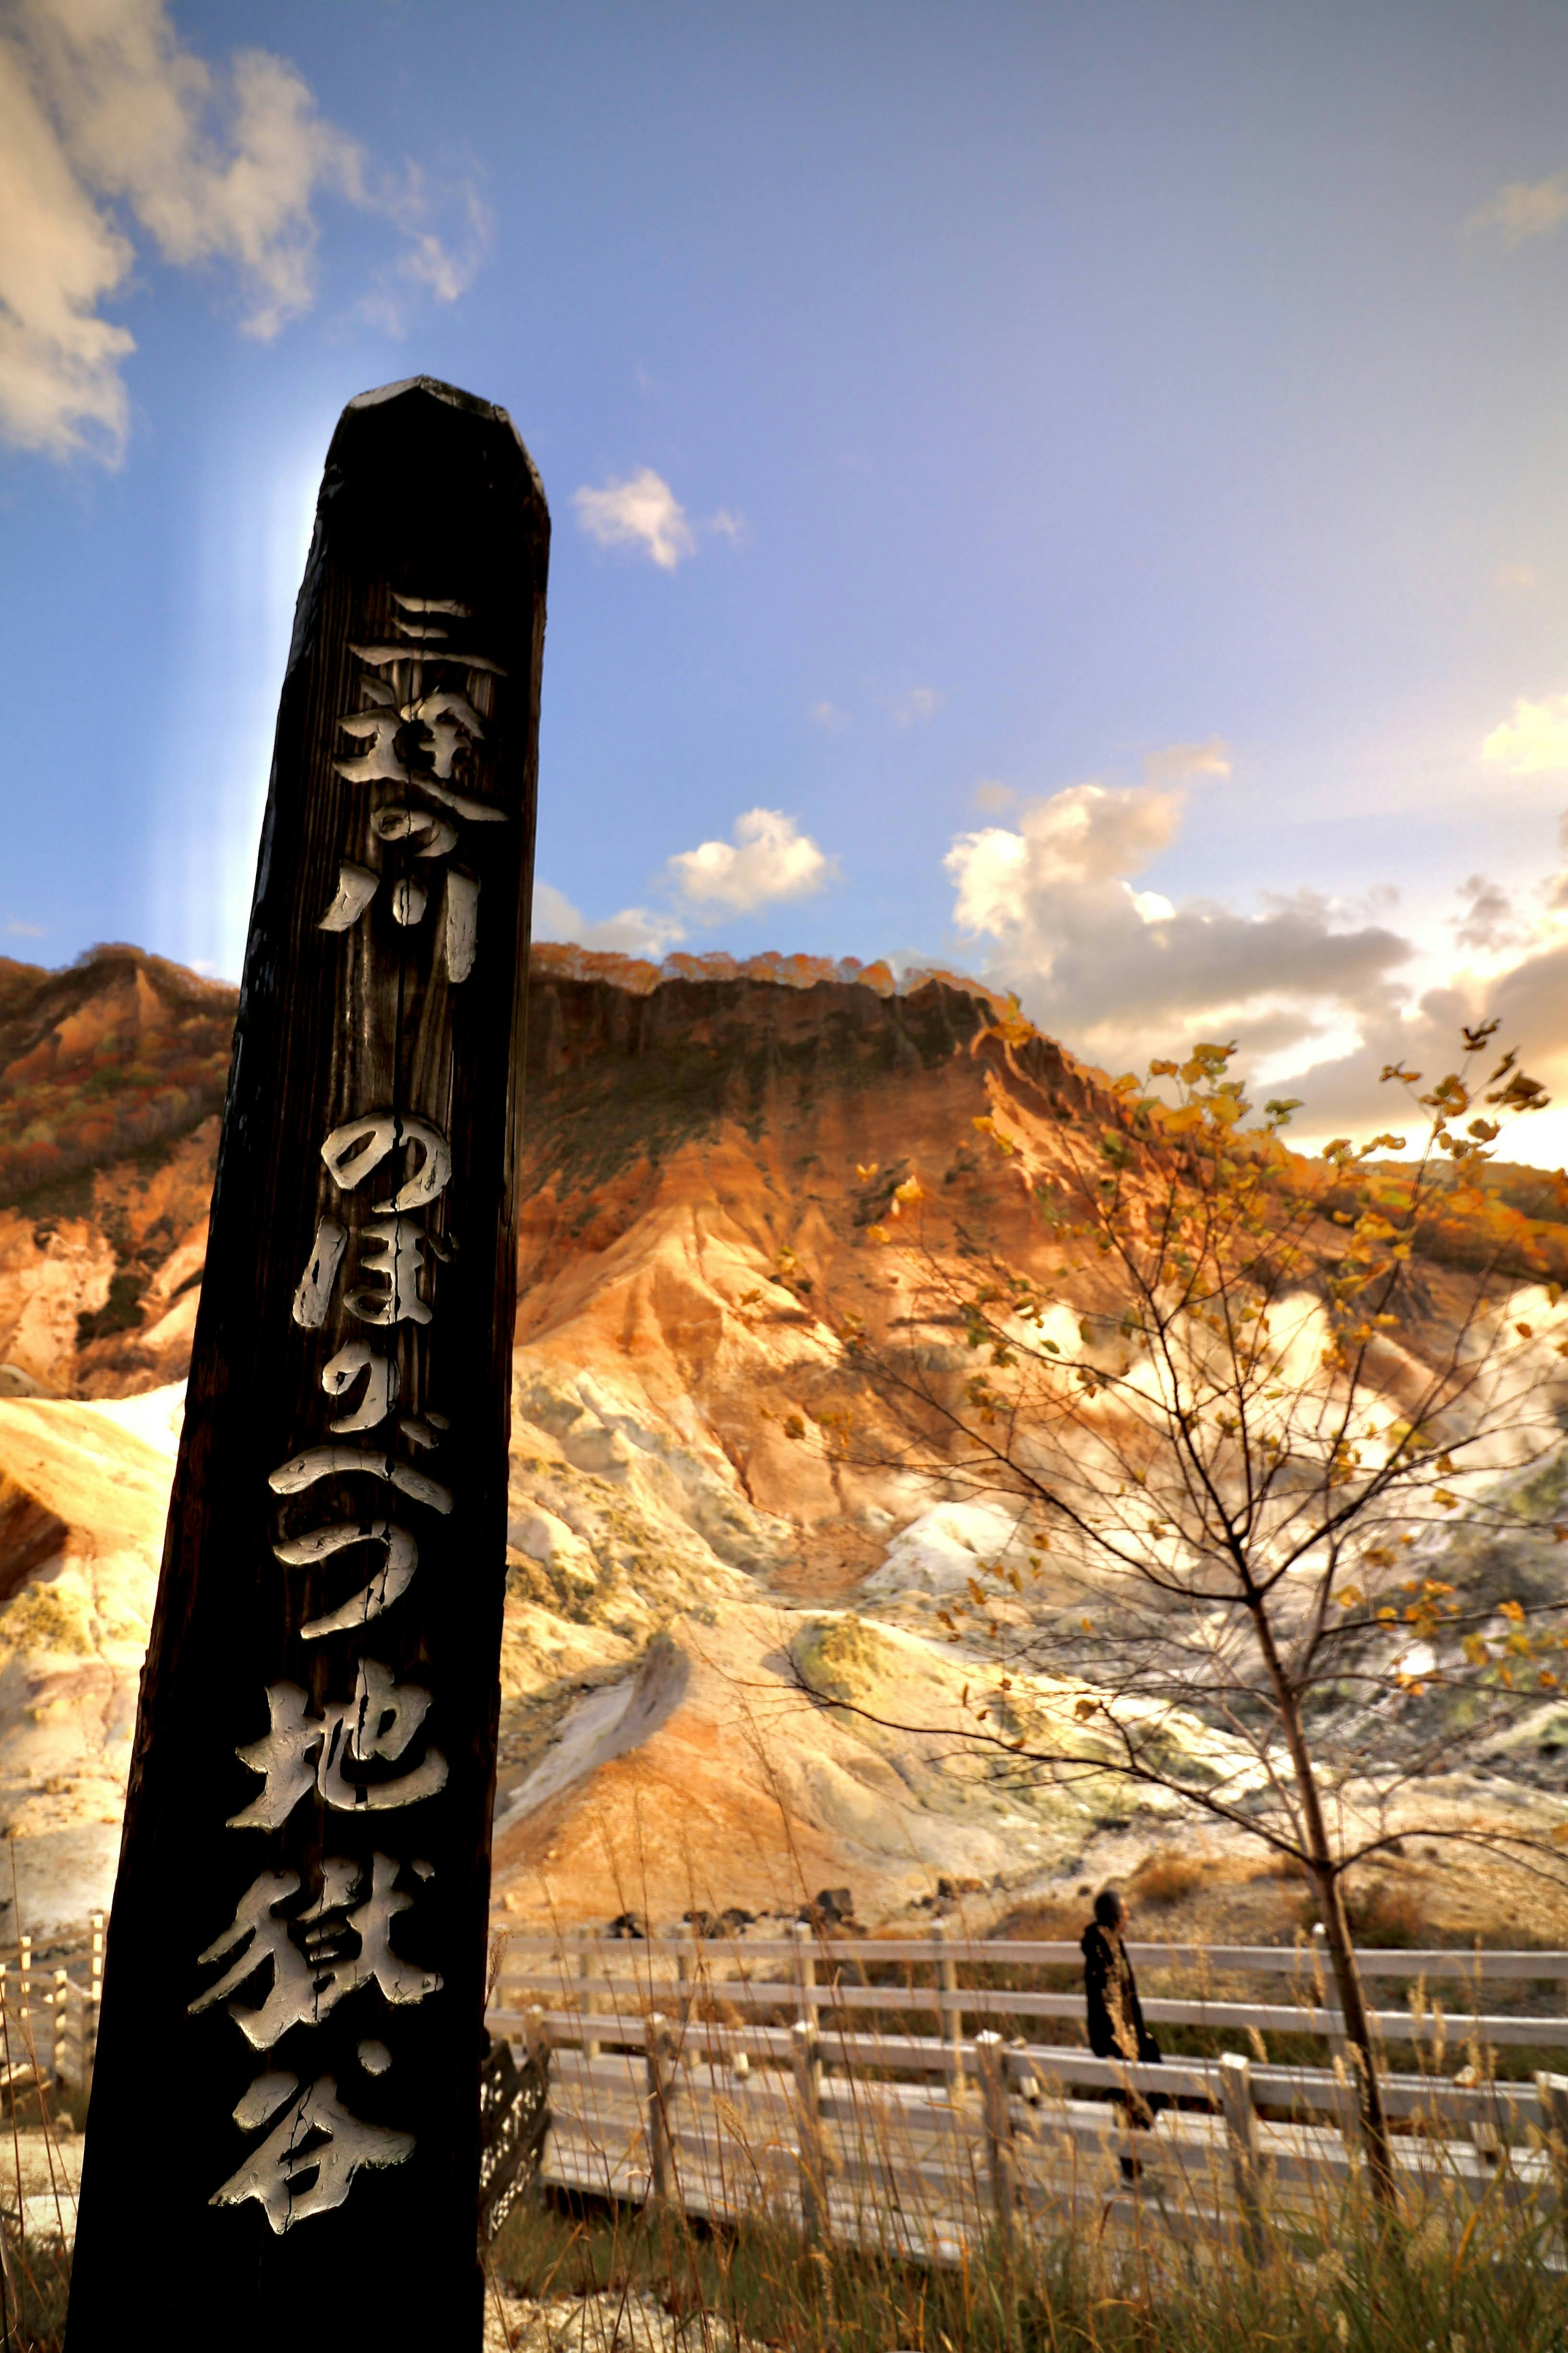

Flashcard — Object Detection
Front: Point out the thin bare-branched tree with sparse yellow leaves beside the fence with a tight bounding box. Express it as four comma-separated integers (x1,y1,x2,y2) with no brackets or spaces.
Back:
813,1021,1568,2198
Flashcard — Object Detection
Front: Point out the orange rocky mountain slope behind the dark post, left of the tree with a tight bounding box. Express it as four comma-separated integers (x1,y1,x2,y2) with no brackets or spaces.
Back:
0,948,1568,1929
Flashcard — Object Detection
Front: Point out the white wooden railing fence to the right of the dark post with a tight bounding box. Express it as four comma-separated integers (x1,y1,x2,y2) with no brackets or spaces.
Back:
489,1927,1568,2261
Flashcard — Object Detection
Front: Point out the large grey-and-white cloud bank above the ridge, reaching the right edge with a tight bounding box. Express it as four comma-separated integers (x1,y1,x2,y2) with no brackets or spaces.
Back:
947,783,1568,1162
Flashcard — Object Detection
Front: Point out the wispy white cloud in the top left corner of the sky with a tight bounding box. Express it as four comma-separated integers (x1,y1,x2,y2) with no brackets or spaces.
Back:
0,0,484,464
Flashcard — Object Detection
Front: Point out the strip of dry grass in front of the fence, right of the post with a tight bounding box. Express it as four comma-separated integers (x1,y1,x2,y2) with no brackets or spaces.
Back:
491,2165,1568,2353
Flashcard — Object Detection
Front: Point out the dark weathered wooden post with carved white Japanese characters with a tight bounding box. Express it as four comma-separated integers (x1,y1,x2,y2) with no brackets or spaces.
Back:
68,377,550,2353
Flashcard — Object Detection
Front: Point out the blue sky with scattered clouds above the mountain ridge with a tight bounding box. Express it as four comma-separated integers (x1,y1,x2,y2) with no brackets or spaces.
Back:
0,0,1568,1160
